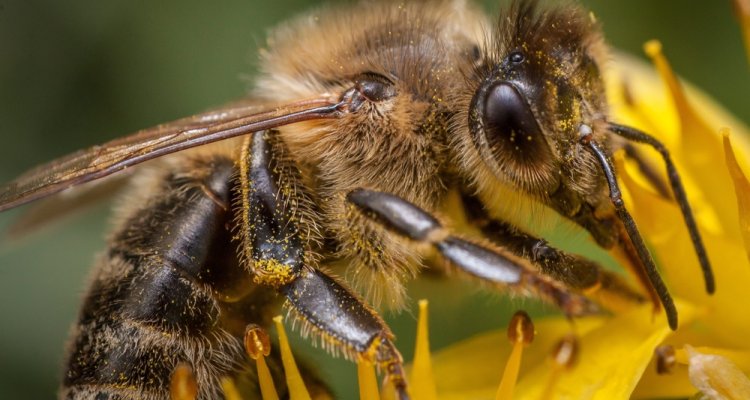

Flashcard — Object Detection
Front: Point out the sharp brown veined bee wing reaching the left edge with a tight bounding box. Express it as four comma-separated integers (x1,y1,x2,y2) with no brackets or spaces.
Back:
0,96,345,211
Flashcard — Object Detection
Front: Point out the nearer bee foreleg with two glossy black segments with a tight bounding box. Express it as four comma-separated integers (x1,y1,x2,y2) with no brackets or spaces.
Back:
348,189,597,316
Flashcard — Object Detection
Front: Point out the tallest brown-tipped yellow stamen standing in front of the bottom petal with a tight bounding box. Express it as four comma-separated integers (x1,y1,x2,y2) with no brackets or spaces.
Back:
495,310,534,400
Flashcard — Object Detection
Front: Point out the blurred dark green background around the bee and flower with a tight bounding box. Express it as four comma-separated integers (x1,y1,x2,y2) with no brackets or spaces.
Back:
0,0,750,399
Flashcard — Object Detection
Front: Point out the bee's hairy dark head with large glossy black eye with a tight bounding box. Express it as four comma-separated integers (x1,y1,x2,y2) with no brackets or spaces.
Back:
468,1,606,194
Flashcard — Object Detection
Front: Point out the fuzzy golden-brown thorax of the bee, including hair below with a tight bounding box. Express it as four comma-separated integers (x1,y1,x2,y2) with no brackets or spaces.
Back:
250,1,484,307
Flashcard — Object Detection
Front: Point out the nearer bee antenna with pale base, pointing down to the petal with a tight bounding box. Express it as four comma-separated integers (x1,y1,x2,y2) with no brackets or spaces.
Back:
580,125,677,330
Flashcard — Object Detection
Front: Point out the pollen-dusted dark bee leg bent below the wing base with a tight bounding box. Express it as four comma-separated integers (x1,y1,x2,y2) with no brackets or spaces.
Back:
237,132,407,399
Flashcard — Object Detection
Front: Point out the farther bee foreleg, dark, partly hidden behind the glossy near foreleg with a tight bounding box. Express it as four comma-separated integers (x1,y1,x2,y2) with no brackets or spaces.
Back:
462,194,644,307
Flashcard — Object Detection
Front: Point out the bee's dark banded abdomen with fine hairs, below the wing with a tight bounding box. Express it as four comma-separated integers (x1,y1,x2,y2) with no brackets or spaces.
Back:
61,159,268,399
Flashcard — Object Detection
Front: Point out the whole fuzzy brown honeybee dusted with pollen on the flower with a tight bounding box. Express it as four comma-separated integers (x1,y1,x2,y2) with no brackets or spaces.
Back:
0,2,724,398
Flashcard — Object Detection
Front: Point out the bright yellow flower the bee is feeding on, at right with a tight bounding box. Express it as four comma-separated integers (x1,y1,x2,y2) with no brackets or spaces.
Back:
420,42,750,400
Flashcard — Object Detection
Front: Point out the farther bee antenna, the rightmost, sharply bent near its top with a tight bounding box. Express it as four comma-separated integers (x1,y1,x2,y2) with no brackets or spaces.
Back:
609,123,716,294
